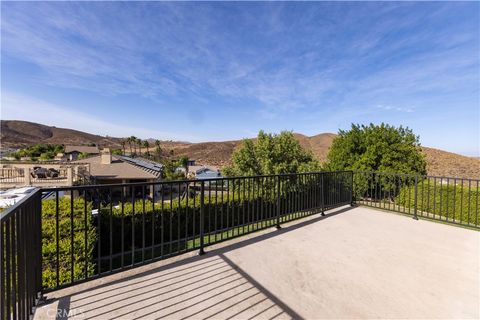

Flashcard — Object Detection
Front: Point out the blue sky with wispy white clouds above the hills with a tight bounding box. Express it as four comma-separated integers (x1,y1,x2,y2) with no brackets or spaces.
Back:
1,2,480,156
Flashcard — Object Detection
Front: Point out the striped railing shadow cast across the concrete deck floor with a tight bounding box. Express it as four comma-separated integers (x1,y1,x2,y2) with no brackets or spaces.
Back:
36,207,351,319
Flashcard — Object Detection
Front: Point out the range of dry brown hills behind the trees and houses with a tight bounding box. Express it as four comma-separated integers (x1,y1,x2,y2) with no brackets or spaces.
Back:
0,120,480,179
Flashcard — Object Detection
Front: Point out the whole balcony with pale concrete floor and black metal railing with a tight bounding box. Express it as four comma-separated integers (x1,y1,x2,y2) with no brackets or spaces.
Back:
1,172,480,319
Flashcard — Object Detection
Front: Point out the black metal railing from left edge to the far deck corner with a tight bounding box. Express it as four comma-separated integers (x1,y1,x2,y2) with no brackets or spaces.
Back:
1,171,353,319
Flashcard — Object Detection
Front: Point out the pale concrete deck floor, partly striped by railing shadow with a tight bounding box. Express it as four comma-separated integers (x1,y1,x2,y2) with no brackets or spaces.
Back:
35,207,480,319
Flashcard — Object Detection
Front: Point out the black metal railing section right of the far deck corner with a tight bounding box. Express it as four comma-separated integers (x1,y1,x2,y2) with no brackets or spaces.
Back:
353,171,480,229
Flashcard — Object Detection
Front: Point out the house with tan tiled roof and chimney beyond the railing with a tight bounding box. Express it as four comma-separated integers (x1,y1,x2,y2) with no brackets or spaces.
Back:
73,149,163,196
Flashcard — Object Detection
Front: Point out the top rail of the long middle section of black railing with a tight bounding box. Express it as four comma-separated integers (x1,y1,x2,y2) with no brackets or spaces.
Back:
41,170,353,192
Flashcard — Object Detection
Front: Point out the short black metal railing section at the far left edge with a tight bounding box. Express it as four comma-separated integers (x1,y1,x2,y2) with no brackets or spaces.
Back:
0,191,42,319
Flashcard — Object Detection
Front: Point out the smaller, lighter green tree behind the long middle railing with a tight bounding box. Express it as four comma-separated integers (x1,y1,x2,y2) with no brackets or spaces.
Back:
224,131,320,176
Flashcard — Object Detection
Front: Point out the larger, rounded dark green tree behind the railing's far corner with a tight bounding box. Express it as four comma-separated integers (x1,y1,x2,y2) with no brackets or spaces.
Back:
325,123,426,174
